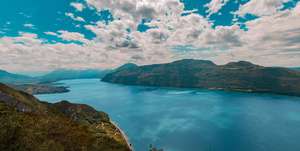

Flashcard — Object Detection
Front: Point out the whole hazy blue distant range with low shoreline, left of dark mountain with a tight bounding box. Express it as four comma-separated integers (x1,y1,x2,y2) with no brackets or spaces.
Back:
0,69,109,94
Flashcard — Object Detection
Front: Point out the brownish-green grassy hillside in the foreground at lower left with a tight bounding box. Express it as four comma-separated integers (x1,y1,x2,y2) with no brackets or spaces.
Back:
0,84,131,151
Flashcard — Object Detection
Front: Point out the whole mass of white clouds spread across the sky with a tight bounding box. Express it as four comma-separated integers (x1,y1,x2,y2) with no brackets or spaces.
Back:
0,0,300,70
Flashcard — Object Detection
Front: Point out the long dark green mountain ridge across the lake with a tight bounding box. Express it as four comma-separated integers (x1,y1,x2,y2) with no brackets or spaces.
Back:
102,59,300,96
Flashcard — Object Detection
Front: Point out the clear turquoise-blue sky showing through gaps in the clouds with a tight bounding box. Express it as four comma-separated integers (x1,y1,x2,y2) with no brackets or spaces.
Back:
0,0,253,38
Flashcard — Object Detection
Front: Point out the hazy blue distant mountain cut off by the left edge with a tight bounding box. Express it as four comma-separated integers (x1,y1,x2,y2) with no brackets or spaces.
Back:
0,70,36,84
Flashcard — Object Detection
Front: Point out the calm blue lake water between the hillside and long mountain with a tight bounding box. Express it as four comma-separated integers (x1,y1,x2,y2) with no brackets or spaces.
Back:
37,79,300,151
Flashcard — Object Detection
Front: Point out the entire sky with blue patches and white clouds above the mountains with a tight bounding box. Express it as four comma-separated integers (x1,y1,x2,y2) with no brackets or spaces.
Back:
0,0,300,72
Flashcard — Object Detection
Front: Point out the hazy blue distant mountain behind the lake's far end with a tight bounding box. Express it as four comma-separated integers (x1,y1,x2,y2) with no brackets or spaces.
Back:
37,69,109,82
